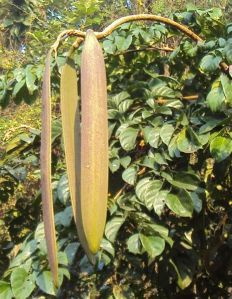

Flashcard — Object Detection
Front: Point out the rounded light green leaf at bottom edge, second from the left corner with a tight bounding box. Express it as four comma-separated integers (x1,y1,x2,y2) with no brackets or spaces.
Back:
10,268,35,299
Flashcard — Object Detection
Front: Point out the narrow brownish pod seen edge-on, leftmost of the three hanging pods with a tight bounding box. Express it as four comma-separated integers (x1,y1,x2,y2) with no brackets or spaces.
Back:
40,51,58,287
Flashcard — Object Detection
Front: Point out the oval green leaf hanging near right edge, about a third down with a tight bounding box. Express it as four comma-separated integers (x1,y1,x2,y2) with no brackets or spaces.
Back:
206,85,225,112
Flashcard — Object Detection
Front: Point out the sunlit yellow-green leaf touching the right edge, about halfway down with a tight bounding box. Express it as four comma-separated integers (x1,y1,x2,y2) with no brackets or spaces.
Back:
210,136,232,162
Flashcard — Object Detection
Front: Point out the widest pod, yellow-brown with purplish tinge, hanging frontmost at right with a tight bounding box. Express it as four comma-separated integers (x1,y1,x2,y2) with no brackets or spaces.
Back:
78,30,108,254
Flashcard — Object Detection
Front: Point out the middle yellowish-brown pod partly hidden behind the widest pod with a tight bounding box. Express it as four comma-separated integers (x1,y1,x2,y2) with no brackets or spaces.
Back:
60,41,94,263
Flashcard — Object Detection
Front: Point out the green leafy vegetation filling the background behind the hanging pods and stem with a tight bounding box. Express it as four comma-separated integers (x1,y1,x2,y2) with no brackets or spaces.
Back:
0,0,232,299
